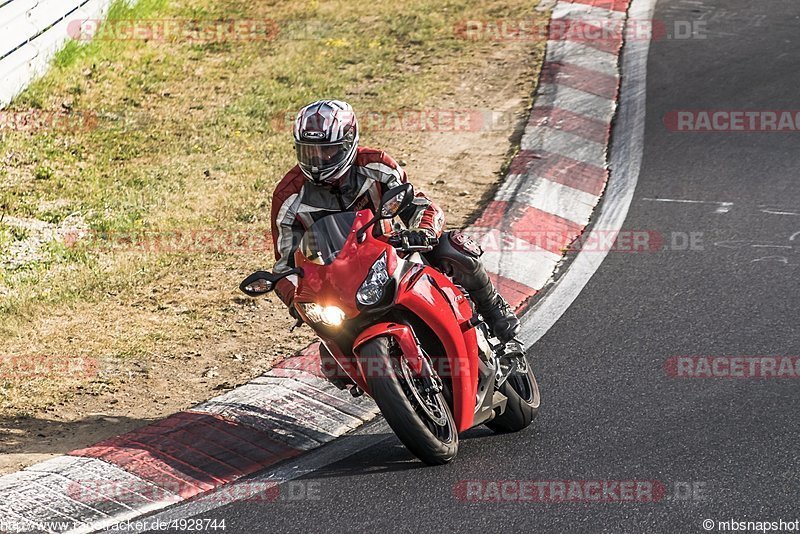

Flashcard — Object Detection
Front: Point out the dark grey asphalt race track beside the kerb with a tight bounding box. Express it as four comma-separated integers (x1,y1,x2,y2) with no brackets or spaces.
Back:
145,0,800,533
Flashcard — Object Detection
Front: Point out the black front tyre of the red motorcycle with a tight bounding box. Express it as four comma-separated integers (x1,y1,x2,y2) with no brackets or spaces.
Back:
358,337,458,465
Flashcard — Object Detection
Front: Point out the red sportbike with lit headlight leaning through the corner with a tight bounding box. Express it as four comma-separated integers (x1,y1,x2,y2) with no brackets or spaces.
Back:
240,184,539,465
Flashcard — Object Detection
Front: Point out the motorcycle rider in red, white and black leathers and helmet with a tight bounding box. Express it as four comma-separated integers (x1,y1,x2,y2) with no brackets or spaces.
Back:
272,100,522,389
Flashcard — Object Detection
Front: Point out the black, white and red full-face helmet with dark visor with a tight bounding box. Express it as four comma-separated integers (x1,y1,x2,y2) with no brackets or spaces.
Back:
294,100,358,185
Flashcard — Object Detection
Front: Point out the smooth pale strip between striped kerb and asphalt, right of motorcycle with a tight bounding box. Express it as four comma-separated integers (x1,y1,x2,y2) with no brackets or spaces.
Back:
522,0,656,346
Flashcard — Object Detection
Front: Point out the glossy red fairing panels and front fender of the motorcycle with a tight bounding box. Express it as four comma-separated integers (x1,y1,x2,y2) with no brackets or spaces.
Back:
295,210,478,432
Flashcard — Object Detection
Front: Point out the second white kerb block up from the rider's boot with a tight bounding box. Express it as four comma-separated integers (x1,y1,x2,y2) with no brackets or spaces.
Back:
495,175,600,226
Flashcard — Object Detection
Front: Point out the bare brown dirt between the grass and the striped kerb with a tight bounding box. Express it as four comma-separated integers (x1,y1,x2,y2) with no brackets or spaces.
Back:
0,35,542,473
